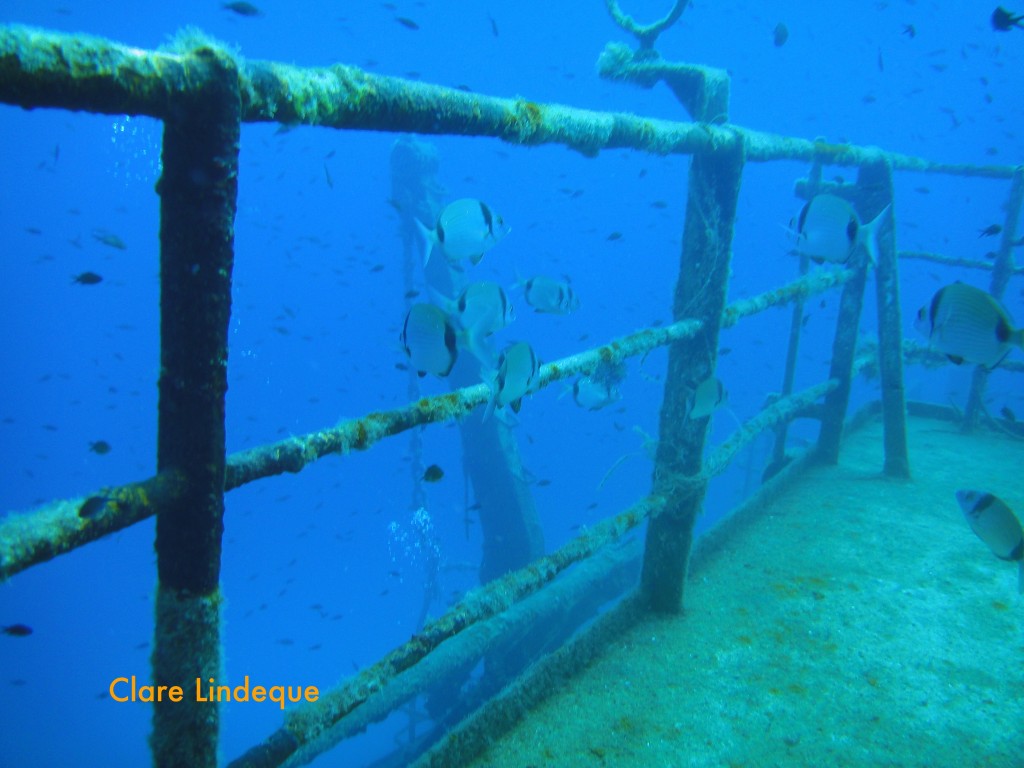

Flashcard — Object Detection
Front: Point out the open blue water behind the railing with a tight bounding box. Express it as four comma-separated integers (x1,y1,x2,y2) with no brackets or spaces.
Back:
0,0,1024,765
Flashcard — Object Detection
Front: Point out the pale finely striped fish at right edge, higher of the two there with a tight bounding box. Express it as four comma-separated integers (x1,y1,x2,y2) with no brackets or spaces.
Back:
913,282,1024,369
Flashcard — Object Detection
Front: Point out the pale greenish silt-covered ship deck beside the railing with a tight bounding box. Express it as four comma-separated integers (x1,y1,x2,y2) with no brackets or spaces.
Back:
474,419,1024,768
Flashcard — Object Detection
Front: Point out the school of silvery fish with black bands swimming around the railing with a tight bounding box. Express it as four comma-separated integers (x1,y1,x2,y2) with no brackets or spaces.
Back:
400,194,1024,591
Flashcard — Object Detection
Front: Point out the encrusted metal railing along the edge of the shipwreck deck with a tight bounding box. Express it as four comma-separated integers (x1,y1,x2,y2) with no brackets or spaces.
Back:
0,19,1022,766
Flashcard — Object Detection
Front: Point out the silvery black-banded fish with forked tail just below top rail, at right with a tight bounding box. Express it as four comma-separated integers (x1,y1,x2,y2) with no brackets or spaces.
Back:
793,195,889,264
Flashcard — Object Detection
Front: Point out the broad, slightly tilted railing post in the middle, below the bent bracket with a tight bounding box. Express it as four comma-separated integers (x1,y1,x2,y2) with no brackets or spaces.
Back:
641,135,744,612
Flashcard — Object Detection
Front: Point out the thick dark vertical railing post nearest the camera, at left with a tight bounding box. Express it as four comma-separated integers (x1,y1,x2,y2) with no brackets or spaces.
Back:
151,48,241,768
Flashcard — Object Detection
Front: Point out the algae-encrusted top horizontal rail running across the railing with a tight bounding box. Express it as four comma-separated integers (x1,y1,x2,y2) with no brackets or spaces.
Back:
0,25,1014,179
